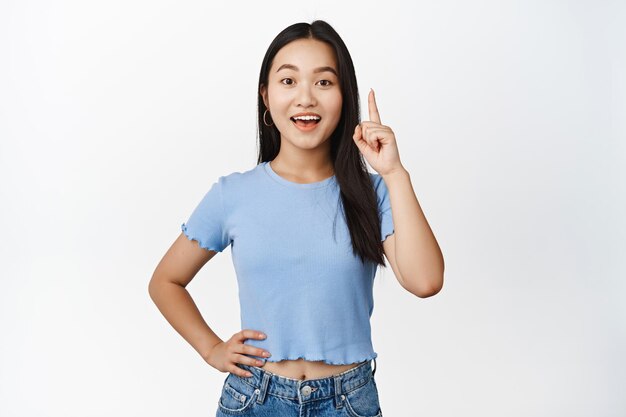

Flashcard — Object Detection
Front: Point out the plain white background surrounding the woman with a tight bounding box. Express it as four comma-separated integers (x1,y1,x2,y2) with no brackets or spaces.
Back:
0,0,626,417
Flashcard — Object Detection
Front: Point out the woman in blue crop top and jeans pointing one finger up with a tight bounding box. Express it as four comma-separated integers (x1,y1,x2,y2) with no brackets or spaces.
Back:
150,20,443,417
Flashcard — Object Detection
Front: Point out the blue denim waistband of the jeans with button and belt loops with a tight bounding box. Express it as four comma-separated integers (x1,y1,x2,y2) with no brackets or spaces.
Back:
232,358,376,403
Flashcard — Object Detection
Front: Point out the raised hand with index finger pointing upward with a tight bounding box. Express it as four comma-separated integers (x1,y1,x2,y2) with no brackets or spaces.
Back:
352,89,404,176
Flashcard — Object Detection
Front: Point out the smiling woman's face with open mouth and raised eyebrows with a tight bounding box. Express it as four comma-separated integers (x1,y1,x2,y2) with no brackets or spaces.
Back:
260,39,342,149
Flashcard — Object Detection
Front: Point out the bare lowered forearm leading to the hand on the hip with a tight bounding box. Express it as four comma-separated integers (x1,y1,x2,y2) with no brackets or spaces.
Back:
149,282,223,360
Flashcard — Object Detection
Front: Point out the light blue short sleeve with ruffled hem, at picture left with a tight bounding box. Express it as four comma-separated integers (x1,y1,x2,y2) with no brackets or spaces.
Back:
181,177,230,252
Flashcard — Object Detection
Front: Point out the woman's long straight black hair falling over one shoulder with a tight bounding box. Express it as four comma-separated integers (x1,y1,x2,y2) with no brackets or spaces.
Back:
257,20,386,266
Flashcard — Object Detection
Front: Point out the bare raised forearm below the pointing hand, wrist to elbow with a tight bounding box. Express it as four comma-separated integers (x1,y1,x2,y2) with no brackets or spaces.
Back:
383,169,444,292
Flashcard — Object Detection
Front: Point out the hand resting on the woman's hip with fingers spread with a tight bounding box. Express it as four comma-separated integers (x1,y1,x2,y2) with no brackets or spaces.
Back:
205,329,270,378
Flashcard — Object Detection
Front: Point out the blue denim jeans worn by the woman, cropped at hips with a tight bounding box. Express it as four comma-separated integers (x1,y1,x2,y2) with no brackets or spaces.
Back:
216,359,383,417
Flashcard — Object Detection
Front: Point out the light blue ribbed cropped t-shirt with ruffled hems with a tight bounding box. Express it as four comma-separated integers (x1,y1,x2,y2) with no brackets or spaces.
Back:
181,162,394,365
